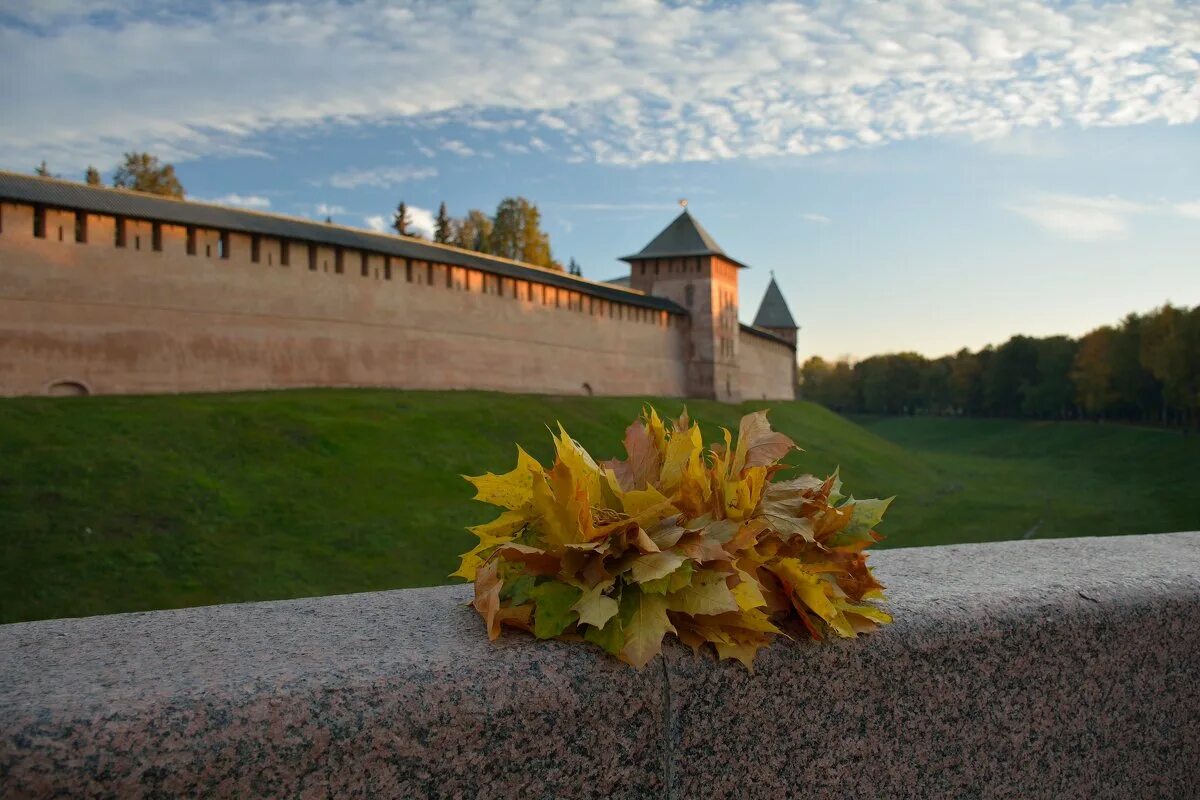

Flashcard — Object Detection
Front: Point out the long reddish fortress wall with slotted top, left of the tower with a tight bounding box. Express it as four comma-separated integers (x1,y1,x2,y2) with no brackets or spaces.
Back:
0,203,688,396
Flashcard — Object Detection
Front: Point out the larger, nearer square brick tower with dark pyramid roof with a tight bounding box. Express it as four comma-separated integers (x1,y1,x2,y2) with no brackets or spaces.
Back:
622,208,745,403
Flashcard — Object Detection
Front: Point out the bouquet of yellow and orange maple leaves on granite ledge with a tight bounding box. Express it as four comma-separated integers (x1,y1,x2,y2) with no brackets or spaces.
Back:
455,409,892,667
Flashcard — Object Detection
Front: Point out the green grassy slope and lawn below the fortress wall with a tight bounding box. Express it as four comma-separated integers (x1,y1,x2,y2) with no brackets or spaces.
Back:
0,390,1200,621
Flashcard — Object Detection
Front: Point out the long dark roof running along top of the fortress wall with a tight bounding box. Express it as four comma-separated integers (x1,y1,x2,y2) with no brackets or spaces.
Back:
0,172,688,314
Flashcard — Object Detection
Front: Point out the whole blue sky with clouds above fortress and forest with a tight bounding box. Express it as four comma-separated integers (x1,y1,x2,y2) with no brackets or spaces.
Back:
0,0,1200,359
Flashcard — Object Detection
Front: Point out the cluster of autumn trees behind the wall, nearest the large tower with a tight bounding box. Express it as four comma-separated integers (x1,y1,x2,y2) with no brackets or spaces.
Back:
391,197,583,275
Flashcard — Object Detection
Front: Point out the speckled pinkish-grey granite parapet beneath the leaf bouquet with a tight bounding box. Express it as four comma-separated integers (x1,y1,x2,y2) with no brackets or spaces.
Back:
0,534,1200,799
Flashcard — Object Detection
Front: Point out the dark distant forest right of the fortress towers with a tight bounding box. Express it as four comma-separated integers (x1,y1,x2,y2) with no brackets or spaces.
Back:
800,306,1200,427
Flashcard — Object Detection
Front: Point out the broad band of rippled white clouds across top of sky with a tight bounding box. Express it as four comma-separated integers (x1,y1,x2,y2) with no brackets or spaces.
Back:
7,0,1200,170
